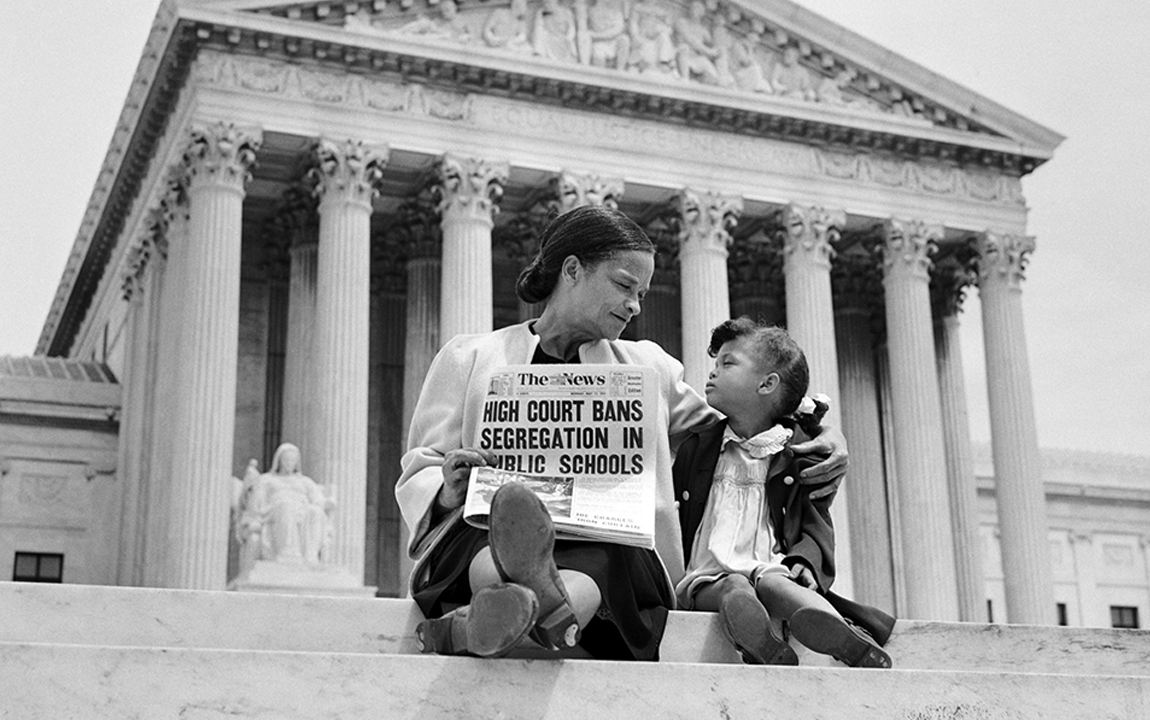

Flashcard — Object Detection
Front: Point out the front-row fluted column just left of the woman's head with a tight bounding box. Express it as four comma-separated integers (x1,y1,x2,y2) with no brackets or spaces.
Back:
437,155,509,343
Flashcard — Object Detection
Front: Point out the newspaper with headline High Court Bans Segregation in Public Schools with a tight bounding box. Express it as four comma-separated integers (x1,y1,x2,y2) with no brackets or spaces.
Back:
463,365,659,547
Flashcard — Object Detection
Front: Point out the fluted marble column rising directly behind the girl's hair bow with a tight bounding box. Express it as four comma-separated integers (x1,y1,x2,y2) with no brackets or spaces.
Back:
780,205,854,597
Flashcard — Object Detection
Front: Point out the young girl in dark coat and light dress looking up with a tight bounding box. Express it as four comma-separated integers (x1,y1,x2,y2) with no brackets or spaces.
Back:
674,317,894,667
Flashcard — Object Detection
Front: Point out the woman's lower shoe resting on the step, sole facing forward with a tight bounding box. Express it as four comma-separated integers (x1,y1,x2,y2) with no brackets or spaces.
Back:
415,583,539,658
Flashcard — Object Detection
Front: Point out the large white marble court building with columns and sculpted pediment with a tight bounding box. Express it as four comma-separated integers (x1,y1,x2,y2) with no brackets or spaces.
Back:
11,0,1104,623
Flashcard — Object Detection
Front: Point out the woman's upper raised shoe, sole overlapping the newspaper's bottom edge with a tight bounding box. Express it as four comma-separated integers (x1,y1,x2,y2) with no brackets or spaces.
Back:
488,482,580,650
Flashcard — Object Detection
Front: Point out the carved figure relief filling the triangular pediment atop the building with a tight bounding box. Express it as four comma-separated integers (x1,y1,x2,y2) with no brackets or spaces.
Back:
343,0,918,115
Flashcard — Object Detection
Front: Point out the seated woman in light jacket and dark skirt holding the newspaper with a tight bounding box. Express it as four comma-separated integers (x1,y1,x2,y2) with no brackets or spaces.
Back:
396,206,846,660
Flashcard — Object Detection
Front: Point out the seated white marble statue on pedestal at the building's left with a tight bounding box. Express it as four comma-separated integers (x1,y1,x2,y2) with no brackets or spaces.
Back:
237,443,335,569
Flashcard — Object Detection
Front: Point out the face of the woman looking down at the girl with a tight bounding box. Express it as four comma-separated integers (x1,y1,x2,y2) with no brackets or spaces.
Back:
565,250,654,340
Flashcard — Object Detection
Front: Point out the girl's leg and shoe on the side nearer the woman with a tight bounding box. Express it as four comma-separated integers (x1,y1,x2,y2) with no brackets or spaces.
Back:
695,575,798,665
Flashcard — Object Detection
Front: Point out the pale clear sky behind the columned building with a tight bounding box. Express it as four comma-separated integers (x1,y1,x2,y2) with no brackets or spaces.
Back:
0,0,1150,455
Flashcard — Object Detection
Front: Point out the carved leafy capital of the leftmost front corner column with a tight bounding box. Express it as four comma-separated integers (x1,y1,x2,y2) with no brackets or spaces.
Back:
175,122,263,193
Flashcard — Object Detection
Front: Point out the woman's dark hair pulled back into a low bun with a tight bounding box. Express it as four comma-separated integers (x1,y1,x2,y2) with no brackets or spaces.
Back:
515,205,654,302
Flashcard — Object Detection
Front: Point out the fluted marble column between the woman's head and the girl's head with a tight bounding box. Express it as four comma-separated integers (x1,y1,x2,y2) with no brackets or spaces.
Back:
674,189,743,392
